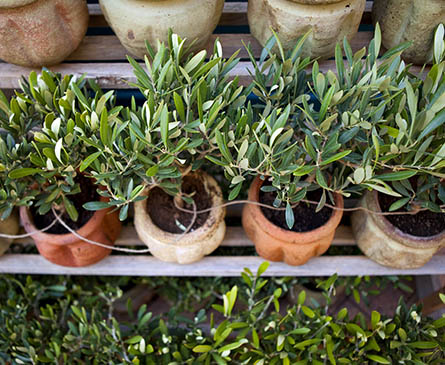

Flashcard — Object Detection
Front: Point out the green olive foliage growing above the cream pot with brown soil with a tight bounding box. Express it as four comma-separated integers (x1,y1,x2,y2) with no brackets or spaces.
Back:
87,34,246,219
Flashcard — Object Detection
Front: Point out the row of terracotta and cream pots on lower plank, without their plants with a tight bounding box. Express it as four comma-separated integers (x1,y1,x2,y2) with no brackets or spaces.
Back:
5,171,445,269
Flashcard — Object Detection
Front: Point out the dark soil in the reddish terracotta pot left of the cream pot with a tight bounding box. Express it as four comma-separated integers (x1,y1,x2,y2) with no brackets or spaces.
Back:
31,175,100,234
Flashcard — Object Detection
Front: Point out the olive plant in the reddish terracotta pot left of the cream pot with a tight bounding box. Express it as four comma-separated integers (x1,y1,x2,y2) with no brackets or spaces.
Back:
8,71,121,266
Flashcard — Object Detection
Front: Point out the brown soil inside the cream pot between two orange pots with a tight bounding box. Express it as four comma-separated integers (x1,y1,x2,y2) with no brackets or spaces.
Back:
147,176,212,234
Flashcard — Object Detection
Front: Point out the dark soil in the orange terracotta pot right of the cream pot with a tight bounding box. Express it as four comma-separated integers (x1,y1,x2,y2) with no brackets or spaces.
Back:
260,186,332,232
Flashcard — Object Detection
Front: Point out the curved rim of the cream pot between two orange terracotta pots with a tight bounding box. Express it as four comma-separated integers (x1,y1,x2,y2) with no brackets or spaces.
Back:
135,170,226,247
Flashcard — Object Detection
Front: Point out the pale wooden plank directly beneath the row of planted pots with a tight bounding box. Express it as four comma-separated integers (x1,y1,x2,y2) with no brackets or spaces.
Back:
0,254,445,277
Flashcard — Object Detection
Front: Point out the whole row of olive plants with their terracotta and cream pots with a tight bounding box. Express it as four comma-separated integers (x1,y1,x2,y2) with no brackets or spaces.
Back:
0,26,445,267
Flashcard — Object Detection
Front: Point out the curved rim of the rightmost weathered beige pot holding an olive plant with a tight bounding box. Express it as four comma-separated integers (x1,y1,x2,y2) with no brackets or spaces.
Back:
364,190,445,248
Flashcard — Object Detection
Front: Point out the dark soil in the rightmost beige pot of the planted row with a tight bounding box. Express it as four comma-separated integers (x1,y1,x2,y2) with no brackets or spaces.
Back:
378,193,445,237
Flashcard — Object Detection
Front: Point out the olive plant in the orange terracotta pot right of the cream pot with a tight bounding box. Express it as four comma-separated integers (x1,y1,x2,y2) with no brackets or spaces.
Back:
209,34,350,265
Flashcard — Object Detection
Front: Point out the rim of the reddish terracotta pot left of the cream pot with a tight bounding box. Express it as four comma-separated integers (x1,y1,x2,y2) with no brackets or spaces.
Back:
20,196,110,246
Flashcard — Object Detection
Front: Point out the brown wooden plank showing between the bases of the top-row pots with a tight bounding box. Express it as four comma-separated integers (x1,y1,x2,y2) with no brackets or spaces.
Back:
67,31,373,62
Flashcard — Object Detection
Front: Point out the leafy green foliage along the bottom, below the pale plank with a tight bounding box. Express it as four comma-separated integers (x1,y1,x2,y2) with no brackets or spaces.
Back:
0,263,445,365
